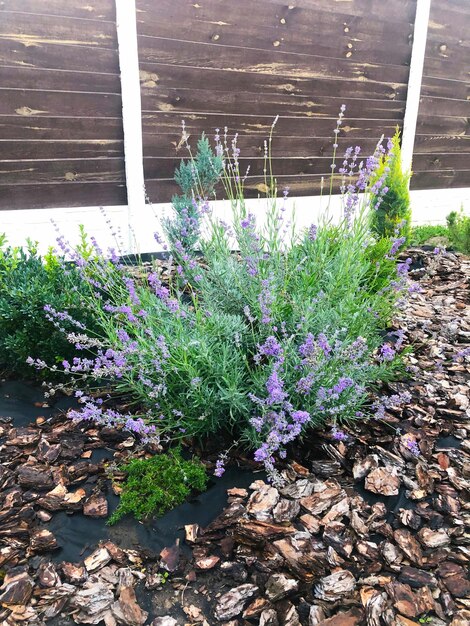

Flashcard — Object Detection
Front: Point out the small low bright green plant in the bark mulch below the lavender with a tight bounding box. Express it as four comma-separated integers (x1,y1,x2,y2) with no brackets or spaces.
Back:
108,448,208,524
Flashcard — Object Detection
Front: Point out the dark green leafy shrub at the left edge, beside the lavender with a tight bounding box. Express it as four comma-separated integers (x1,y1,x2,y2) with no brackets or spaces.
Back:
0,238,97,377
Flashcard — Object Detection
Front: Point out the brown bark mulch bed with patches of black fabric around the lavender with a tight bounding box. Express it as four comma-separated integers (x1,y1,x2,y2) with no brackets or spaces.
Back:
0,249,470,626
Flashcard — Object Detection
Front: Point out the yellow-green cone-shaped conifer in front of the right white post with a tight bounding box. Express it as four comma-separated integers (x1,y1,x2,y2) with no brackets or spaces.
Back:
371,129,411,238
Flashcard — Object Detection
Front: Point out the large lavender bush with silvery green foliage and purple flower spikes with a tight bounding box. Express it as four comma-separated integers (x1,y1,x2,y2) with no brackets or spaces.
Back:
30,111,409,477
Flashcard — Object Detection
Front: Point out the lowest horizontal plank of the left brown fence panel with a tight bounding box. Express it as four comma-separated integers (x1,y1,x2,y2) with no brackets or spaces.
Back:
0,182,127,210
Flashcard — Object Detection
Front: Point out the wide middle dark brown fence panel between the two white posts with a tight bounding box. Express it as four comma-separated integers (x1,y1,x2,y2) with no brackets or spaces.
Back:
137,0,414,202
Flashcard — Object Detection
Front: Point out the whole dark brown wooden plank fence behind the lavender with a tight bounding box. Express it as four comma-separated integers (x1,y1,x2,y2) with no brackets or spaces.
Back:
0,0,470,209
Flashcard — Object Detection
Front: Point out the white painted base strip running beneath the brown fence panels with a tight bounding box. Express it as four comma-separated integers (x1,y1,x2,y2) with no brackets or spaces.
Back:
0,188,470,253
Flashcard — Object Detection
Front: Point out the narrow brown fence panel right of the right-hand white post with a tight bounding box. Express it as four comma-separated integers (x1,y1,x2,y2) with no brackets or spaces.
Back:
411,0,470,190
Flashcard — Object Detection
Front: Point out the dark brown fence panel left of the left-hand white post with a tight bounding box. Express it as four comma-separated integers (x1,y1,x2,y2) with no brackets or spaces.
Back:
0,0,127,209
